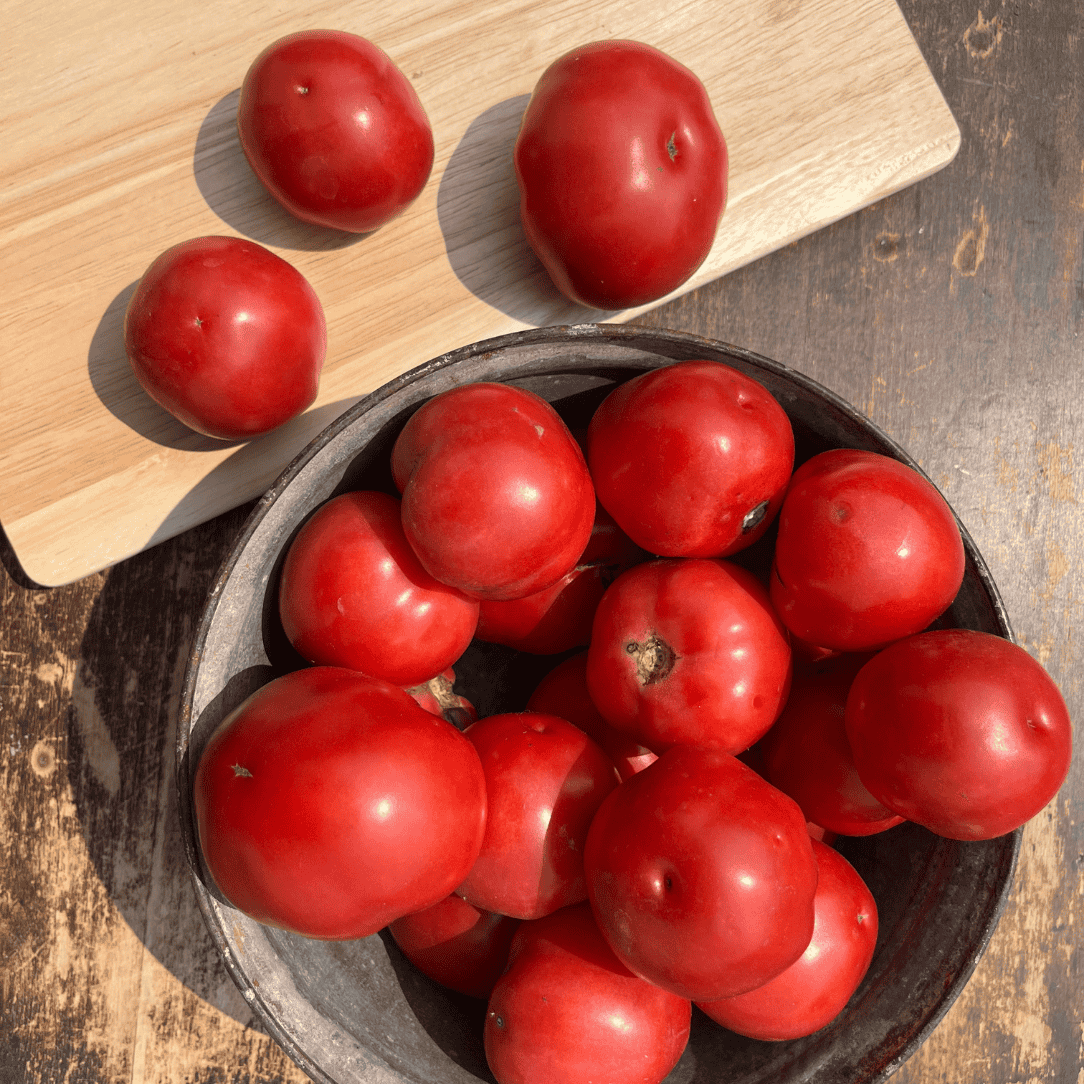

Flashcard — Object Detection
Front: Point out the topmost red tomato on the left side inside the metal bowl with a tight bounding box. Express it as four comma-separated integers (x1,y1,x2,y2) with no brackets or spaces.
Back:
391,383,595,598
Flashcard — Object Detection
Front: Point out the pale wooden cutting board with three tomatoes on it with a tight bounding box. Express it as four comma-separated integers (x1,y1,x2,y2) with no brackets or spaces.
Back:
0,0,959,585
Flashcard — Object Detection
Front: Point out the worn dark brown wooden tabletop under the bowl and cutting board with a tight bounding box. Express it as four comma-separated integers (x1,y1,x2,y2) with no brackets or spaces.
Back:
0,0,1084,1084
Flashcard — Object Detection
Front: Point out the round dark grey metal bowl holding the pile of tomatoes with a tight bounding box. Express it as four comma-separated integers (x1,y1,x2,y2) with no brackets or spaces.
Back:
177,324,1020,1084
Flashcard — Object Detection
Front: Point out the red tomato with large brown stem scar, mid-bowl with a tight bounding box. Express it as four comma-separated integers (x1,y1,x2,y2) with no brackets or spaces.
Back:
586,558,790,752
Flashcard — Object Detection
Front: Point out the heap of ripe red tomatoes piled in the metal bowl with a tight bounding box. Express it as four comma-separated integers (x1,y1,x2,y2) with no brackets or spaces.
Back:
194,361,1071,1084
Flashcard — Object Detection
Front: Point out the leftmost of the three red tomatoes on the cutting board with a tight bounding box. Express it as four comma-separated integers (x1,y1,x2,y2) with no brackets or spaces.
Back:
125,237,327,440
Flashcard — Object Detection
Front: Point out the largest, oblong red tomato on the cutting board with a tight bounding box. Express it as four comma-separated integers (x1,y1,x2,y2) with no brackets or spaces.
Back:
514,41,727,309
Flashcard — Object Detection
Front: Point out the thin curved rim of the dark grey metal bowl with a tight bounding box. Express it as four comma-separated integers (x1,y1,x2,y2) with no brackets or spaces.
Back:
175,323,1023,1084
